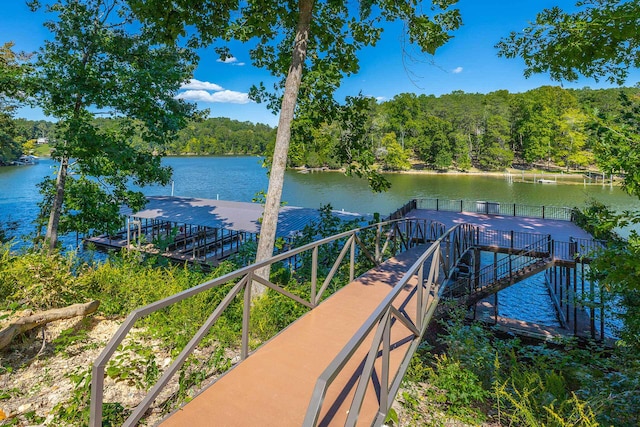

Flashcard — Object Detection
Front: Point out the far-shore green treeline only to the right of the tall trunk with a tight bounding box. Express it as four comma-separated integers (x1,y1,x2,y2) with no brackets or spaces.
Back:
290,86,640,170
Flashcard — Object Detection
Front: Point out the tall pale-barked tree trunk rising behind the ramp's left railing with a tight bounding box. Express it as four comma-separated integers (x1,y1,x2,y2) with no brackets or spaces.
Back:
252,0,313,296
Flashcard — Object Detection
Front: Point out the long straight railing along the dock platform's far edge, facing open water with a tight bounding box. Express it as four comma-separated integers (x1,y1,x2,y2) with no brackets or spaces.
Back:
416,199,574,221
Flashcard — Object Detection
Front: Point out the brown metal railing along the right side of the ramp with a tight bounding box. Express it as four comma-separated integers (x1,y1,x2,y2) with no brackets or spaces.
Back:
303,224,475,426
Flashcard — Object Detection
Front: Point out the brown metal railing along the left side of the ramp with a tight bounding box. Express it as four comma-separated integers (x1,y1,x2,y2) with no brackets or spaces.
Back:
90,219,444,427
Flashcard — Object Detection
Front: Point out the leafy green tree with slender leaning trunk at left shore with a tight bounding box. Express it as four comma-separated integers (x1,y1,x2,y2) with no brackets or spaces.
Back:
31,0,195,249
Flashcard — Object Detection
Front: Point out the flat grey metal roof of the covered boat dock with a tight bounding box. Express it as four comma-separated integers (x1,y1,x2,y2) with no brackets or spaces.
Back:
121,196,364,237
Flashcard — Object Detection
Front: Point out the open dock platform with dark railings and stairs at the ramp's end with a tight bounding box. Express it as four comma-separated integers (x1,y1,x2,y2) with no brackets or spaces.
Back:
390,199,605,340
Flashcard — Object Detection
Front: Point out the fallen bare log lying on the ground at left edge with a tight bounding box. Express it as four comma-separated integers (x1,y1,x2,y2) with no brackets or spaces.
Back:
0,301,100,349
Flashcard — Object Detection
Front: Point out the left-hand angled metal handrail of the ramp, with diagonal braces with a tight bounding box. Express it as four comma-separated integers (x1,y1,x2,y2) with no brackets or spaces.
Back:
90,219,444,427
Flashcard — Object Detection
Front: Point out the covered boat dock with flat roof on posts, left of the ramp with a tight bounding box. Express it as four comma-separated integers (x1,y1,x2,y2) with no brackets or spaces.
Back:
85,196,362,267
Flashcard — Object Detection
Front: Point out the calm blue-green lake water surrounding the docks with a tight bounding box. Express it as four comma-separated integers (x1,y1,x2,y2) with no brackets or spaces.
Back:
0,157,640,325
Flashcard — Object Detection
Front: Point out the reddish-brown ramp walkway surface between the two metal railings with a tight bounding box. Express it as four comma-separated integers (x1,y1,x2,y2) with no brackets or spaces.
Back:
161,246,428,427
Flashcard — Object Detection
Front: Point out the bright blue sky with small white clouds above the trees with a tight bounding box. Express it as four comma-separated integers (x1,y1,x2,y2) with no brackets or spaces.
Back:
0,0,640,125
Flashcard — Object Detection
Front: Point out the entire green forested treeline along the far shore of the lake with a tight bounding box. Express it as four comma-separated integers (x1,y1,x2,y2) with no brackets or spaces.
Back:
6,86,640,171
